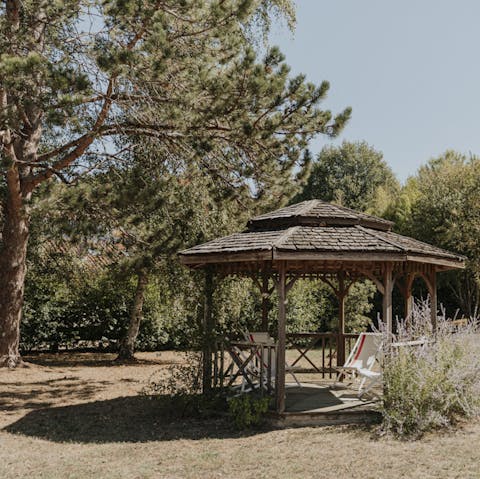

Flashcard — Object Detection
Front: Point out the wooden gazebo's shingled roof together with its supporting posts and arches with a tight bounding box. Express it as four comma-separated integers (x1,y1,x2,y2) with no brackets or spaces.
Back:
179,200,465,413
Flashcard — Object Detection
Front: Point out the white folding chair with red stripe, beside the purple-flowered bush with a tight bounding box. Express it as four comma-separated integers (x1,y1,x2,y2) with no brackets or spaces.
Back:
335,333,382,398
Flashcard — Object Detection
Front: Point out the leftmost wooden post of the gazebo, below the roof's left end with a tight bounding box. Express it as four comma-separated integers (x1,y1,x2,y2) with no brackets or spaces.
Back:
202,268,214,394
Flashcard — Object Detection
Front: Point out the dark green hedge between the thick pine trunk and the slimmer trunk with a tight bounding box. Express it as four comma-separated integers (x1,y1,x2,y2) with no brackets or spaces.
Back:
21,268,133,350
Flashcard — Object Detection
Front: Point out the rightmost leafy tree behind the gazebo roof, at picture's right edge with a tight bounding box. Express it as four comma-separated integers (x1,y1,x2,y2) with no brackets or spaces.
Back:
390,151,480,316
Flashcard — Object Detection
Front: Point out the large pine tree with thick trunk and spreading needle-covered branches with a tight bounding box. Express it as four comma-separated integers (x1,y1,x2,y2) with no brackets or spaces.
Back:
0,0,350,367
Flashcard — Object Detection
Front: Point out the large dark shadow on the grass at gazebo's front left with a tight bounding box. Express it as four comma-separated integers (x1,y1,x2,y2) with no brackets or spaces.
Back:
3,396,266,443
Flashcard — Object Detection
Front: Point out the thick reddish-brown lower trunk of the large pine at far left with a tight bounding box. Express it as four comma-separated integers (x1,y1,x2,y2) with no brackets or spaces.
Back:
0,178,29,368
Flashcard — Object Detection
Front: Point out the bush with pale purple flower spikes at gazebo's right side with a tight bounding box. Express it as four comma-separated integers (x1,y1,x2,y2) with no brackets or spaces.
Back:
382,304,480,438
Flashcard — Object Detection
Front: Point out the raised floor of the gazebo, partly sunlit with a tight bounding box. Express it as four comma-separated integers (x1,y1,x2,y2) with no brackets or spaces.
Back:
270,383,380,427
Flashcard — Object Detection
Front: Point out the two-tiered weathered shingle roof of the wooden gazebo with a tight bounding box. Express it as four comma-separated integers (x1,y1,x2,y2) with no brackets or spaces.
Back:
180,200,465,269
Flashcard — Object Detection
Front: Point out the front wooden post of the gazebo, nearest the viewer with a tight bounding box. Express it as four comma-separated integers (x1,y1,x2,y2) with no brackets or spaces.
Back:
275,261,287,414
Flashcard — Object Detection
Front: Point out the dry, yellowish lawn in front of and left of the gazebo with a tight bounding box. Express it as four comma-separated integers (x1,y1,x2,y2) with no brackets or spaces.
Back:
0,352,480,479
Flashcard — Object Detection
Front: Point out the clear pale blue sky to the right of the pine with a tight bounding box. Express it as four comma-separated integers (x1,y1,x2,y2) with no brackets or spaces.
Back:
271,0,480,181
